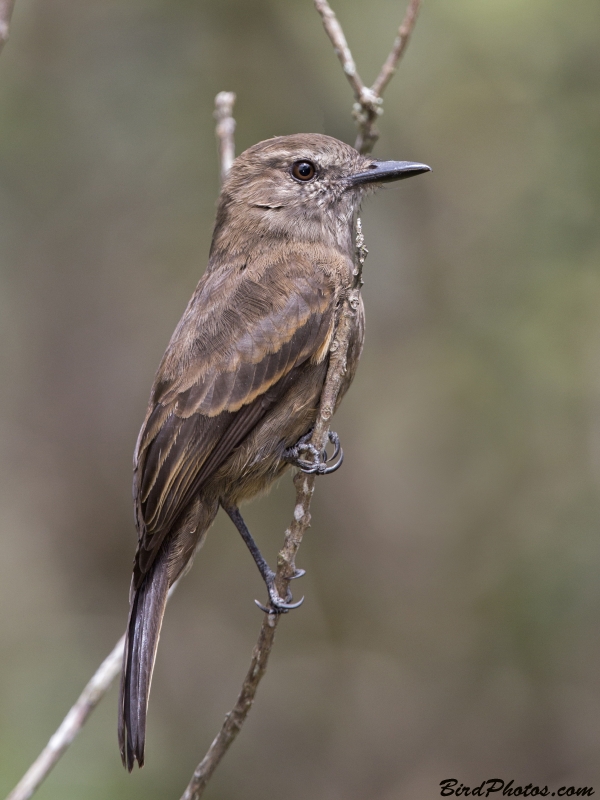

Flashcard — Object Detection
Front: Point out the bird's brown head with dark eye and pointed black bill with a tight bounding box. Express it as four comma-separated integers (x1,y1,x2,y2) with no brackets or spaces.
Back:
213,133,430,260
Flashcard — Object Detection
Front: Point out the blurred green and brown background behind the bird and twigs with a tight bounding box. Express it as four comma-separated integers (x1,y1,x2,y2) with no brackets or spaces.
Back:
0,0,600,800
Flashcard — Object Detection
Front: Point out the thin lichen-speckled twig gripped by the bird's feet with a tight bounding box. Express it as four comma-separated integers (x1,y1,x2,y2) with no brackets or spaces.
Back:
181,219,367,800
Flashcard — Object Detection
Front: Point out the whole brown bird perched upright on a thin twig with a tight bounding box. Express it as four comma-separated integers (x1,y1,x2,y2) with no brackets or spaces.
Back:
119,134,429,770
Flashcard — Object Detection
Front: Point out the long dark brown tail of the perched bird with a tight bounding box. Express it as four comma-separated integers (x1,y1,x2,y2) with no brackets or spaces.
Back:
119,546,169,772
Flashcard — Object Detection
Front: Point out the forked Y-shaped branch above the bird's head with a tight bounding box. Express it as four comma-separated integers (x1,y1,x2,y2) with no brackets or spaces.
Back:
315,0,421,155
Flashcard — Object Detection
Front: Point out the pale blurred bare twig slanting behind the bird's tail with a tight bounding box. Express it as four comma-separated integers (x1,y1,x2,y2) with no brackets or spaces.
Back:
6,636,125,800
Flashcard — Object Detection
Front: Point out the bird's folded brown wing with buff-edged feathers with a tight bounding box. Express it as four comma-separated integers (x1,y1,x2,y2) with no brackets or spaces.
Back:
134,258,336,577
